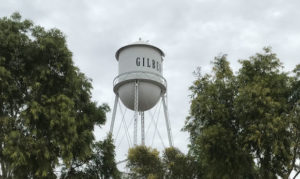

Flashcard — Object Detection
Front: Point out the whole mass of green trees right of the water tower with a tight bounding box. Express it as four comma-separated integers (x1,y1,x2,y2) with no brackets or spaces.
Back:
184,48,300,178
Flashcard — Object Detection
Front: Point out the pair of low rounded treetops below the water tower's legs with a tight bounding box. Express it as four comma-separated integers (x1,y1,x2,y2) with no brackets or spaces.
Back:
127,146,199,179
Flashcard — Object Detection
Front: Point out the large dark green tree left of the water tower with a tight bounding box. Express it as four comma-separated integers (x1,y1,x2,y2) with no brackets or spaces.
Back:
0,13,108,178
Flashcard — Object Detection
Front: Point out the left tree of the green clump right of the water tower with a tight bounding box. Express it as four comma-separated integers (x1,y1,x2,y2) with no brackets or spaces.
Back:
184,55,254,178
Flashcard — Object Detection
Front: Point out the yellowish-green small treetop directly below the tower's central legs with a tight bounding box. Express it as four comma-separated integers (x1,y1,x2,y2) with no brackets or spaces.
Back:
126,146,164,179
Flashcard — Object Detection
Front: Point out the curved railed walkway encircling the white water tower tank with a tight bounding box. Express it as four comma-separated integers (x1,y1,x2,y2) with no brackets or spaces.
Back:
113,71,167,88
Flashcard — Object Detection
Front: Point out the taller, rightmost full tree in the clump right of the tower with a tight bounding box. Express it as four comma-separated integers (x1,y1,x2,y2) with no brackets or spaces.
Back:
235,48,292,178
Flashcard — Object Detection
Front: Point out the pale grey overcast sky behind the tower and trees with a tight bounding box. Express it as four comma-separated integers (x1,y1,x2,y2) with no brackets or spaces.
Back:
0,0,300,171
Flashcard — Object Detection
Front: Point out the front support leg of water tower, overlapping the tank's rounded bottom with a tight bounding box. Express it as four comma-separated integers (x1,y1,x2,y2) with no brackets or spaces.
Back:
133,80,139,146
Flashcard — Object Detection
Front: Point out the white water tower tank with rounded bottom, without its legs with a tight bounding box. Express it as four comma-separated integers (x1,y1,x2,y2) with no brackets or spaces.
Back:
114,40,167,111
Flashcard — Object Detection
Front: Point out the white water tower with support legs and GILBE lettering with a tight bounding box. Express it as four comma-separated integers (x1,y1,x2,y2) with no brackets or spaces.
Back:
110,39,173,146
